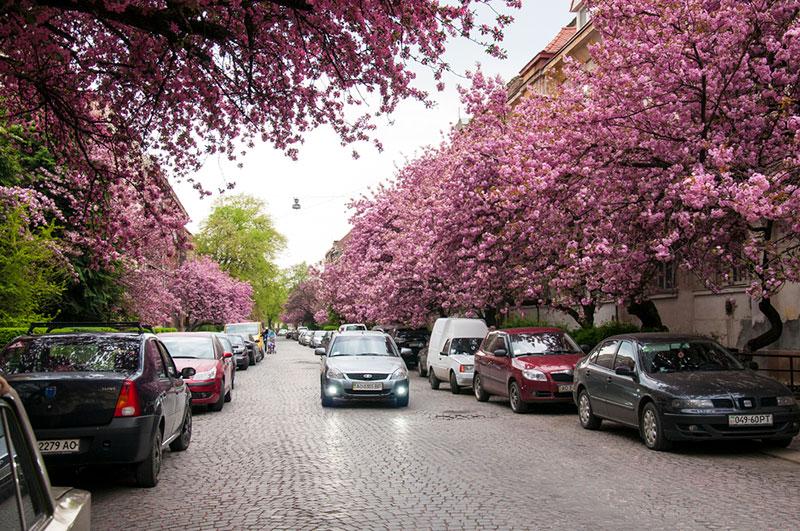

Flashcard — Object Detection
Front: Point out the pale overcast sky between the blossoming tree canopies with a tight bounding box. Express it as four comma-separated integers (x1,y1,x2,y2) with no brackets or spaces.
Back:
175,0,572,267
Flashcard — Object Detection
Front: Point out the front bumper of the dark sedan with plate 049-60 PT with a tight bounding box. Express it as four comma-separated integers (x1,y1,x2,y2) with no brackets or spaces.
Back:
661,411,800,441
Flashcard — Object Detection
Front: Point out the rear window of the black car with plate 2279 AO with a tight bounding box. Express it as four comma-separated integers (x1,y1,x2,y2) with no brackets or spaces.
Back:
0,336,140,375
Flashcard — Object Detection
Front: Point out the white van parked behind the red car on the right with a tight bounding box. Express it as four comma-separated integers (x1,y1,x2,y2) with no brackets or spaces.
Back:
425,317,489,394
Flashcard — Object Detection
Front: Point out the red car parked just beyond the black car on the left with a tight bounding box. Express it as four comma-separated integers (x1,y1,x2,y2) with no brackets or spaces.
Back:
159,332,235,411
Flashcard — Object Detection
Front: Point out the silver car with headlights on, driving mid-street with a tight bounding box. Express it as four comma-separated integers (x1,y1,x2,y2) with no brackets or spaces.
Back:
314,332,409,407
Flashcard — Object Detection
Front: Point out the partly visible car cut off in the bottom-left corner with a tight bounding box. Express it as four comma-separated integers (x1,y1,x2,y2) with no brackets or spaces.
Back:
0,378,92,531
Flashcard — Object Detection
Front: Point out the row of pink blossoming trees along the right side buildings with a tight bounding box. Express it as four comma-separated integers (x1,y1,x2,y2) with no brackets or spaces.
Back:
323,0,800,354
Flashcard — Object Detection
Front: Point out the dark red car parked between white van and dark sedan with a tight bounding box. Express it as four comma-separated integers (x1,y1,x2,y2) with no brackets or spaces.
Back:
472,328,584,413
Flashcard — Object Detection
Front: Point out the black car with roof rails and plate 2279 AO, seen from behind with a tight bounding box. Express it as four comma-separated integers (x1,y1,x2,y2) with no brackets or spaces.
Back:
0,324,195,487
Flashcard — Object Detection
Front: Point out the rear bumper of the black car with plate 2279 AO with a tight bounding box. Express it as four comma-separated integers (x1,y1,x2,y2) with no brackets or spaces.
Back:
34,415,157,467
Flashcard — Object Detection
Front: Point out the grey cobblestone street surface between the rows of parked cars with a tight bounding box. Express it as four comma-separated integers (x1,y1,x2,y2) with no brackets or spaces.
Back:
80,340,800,530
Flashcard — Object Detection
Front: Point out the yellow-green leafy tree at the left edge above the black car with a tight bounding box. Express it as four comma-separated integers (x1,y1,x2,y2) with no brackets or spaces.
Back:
0,208,68,325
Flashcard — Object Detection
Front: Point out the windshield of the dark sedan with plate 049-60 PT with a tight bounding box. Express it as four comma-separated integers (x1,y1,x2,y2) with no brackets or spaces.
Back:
642,341,744,374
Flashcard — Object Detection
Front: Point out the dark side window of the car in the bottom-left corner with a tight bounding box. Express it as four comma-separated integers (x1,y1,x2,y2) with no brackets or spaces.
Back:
0,407,47,529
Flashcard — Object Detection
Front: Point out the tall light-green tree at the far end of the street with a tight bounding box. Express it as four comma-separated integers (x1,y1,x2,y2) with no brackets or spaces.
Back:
195,194,287,325
